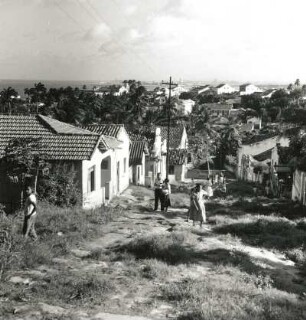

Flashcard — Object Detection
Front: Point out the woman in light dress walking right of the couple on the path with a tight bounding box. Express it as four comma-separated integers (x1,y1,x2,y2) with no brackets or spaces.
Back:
189,184,207,227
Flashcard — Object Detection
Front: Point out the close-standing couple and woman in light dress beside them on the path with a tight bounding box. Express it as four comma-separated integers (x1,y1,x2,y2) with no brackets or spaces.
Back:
154,173,213,226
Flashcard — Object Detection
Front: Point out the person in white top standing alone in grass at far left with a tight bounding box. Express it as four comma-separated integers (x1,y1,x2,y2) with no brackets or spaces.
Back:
23,186,38,240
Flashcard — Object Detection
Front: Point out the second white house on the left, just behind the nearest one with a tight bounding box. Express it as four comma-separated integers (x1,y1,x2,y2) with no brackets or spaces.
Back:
83,124,130,195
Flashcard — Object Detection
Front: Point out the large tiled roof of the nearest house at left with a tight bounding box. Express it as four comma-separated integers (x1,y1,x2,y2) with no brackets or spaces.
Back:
0,115,103,160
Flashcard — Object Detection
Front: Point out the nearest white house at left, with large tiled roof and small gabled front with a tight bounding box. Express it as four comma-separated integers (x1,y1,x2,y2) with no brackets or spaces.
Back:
0,115,121,209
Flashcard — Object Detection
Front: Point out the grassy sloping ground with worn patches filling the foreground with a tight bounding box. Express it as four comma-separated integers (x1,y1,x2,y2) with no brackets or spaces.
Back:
0,186,306,320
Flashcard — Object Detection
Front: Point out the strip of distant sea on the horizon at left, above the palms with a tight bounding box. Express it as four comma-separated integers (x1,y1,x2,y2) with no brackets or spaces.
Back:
0,80,106,97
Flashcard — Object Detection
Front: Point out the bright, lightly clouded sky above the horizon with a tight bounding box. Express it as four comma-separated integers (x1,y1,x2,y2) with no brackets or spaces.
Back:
0,0,306,84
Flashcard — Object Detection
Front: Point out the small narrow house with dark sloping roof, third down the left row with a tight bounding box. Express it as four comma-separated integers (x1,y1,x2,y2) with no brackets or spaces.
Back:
129,141,149,185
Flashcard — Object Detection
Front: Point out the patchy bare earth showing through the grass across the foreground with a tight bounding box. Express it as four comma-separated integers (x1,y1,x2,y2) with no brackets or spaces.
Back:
0,187,306,320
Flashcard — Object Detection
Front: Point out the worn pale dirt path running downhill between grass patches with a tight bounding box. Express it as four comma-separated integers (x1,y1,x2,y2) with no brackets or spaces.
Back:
5,187,305,320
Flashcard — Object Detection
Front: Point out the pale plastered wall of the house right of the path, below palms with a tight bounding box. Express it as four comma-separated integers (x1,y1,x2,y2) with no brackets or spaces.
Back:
237,136,289,178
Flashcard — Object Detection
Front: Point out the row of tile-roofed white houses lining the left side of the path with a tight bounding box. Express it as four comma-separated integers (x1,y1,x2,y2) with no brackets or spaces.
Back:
0,115,188,208
